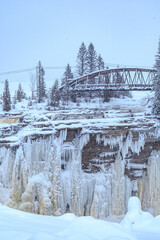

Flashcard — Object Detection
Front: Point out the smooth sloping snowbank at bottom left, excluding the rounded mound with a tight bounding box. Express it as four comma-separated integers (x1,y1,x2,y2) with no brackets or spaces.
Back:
0,202,136,240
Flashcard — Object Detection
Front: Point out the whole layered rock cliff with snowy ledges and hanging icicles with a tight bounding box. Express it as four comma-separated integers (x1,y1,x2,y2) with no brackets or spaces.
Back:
0,106,160,219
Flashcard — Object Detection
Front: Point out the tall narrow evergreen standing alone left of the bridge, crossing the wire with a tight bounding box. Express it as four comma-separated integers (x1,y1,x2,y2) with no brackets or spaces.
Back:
37,61,46,103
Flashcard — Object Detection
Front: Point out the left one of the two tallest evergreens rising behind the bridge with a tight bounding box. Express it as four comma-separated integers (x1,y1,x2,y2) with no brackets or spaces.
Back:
77,42,87,76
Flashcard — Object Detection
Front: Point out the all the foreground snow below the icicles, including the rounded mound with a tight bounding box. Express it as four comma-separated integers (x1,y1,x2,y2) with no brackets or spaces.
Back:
0,197,160,240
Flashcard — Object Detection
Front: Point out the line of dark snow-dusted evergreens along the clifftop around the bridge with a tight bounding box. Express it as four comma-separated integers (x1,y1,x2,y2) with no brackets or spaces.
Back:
2,40,160,115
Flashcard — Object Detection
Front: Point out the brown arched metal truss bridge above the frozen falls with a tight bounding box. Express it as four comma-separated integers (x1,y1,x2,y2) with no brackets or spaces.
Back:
61,67,156,92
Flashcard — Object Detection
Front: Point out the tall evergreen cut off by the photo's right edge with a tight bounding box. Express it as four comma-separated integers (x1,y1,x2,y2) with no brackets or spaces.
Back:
153,39,160,115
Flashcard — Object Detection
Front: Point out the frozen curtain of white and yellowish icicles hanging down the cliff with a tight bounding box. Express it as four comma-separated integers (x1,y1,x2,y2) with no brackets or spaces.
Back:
0,129,160,219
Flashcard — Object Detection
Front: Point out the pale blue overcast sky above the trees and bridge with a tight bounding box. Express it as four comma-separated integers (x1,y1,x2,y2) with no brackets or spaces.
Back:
0,0,160,93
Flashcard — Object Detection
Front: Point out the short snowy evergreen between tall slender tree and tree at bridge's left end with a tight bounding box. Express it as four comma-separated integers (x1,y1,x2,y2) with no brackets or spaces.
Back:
50,79,60,107
